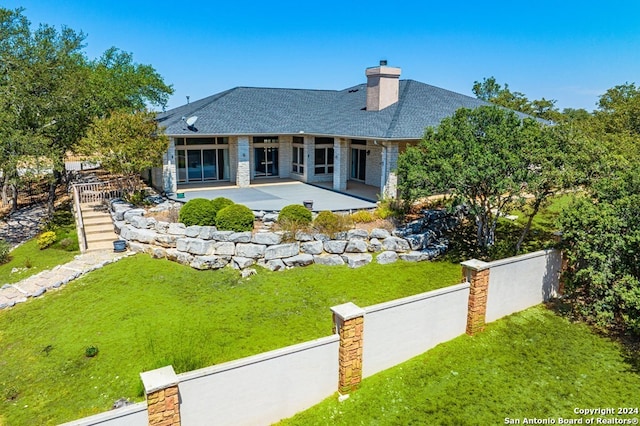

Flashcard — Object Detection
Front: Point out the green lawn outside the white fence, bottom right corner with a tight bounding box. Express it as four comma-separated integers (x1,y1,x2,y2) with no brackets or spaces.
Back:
281,306,640,426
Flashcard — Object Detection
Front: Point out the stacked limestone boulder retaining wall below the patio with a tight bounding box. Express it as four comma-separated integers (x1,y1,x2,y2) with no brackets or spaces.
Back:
111,200,446,271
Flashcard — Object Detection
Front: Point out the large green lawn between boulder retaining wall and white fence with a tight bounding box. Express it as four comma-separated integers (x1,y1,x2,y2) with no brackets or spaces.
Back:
0,255,461,425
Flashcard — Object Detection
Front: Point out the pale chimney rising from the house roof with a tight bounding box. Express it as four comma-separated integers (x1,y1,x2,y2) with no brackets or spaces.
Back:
366,60,401,111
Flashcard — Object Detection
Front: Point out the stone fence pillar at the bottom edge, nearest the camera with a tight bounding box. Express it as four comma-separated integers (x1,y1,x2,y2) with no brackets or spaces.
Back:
140,365,180,426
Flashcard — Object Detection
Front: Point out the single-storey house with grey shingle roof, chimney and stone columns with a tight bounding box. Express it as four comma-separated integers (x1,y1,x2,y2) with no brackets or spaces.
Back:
152,61,486,201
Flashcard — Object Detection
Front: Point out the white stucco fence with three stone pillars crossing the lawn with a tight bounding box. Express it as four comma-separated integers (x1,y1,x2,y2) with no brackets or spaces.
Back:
60,250,561,426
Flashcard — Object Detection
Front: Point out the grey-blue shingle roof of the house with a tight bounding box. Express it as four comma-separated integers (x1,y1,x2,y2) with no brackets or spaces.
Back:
158,80,496,139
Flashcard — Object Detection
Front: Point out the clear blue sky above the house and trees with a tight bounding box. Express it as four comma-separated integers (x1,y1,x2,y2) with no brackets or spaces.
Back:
5,0,640,111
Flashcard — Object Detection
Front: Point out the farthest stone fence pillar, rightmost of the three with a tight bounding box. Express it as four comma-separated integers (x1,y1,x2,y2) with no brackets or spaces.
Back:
461,259,491,336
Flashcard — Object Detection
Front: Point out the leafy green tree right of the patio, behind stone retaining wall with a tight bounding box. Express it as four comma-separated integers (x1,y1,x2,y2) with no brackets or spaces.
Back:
398,106,528,249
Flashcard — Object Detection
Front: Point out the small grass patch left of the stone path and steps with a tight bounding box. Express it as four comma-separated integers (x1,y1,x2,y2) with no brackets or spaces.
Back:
0,225,80,286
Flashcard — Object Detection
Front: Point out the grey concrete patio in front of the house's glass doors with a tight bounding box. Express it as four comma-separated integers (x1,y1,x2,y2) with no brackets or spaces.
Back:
170,180,376,212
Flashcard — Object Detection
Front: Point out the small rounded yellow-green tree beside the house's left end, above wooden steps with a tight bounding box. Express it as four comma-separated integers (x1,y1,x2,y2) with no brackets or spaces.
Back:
78,110,169,180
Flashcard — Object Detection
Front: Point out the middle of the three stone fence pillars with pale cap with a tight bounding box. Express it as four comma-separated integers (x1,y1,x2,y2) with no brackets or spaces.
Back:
331,302,364,395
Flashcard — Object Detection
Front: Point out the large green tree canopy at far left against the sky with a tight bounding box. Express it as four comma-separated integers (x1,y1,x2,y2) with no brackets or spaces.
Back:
0,8,172,213
